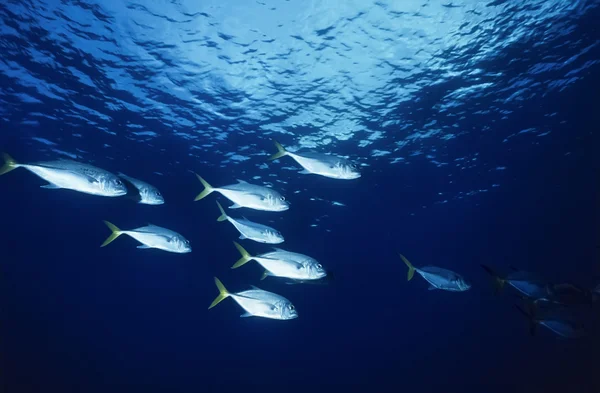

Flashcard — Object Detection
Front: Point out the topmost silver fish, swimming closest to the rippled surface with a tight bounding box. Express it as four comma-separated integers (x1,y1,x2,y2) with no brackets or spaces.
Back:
269,140,361,180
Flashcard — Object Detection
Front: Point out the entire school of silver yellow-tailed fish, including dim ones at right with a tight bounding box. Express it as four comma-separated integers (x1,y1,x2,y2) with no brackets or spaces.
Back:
0,141,600,332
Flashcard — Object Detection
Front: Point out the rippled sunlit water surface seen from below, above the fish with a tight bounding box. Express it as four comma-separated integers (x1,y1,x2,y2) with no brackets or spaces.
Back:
0,0,599,201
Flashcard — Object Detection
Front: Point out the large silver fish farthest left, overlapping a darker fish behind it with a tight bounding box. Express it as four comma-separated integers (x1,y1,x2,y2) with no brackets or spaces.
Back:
0,153,127,197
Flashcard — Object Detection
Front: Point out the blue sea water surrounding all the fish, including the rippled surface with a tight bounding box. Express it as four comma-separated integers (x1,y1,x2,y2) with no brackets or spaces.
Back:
0,0,600,393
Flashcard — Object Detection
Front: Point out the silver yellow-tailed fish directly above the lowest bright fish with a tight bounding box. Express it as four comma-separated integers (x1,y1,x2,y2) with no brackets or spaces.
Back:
231,242,327,281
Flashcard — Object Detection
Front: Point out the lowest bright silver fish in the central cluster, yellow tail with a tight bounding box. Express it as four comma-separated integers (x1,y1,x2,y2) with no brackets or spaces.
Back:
208,277,298,320
